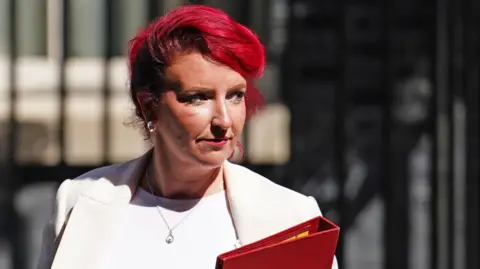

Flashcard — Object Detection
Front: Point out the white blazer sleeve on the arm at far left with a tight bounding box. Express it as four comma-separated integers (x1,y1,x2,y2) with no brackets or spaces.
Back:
37,180,70,269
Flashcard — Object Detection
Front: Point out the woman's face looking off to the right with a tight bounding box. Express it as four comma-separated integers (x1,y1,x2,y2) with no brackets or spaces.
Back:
146,53,246,167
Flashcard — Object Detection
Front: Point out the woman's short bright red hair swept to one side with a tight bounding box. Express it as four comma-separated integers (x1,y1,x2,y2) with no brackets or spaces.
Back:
128,5,265,131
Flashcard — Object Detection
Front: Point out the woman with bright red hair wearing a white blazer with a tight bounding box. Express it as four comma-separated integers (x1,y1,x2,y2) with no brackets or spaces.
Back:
39,6,338,269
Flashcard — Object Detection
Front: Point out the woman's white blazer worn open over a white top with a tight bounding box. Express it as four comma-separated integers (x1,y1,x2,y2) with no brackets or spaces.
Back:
38,151,337,269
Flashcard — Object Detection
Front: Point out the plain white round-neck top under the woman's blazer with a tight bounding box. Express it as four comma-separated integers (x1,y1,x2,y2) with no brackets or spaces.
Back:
98,188,237,269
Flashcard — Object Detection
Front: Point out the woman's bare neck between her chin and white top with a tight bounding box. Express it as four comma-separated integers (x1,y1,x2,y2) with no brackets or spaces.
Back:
145,152,224,199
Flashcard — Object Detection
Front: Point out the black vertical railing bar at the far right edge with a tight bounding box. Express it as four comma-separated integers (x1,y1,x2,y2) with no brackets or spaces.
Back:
462,0,480,268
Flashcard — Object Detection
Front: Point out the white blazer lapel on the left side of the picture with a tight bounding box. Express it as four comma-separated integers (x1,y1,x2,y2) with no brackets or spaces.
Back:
52,151,151,269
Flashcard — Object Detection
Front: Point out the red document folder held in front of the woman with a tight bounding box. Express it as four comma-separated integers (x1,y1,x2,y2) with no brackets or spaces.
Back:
215,217,340,269
